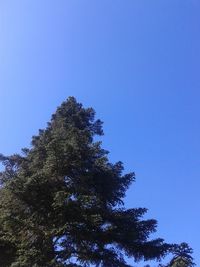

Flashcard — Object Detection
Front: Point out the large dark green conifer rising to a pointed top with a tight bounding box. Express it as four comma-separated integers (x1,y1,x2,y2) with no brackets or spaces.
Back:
0,97,194,267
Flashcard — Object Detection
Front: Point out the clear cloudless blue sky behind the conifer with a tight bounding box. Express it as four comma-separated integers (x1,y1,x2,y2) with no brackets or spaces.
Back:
0,0,200,265
